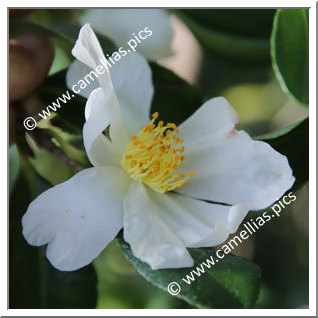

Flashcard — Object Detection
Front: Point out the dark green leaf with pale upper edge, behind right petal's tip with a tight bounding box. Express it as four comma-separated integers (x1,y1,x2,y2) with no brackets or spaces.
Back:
255,118,309,189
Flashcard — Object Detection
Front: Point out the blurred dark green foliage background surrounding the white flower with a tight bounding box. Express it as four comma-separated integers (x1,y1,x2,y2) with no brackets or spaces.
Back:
9,9,309,308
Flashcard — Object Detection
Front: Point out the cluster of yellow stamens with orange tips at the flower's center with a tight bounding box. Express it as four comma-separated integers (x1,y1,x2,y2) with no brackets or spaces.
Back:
121,112,194,193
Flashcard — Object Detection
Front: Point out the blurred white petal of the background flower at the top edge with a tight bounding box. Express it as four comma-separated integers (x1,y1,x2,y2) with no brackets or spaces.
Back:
81,9,173,60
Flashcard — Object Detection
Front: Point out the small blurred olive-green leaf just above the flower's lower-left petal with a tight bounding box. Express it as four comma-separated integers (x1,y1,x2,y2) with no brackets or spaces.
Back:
26,134,75,185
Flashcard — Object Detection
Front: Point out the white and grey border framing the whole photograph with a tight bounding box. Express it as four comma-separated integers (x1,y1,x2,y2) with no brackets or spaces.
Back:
0,0,317,316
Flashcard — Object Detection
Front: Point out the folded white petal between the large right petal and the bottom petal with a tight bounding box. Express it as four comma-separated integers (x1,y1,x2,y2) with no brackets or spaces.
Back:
149,191,248,247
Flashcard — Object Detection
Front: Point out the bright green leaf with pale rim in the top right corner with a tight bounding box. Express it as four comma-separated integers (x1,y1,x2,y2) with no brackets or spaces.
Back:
271,9,309,106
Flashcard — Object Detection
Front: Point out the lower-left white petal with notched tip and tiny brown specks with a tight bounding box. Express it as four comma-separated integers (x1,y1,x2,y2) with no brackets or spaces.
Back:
22,168,128,271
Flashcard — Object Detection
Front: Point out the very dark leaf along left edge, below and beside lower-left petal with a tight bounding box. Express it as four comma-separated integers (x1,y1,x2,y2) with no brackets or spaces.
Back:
9,161,42,309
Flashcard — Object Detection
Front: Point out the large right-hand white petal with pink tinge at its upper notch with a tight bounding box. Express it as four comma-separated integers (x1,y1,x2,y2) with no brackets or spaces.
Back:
176,98,295,210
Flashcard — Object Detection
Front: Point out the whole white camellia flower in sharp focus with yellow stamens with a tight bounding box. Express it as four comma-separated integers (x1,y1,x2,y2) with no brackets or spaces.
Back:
22,25,294,271
